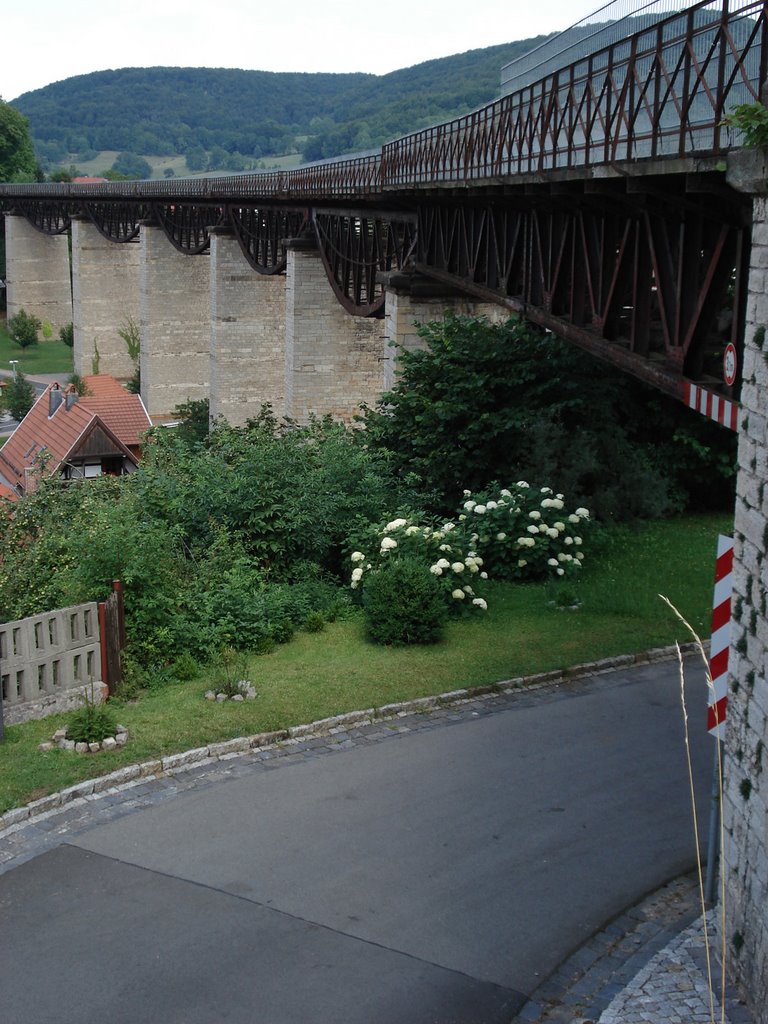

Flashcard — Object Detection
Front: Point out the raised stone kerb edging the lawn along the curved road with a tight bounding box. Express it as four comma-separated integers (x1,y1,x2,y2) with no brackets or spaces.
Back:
0,643,695,840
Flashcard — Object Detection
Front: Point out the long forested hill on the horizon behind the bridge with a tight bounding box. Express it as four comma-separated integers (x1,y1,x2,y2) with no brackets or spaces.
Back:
12,37,544,170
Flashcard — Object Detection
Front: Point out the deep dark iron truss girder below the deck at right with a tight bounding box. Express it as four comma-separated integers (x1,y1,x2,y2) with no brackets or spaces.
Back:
416,182,750,400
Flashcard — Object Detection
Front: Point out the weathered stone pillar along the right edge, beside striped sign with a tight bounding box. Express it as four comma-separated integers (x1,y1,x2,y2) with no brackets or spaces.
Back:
722,150,768,1024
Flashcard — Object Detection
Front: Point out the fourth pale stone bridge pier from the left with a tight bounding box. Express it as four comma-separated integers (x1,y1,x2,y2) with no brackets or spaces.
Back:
210,227,286,427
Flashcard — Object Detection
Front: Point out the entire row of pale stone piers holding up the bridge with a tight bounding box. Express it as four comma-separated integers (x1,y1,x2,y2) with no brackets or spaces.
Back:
5,215,499,426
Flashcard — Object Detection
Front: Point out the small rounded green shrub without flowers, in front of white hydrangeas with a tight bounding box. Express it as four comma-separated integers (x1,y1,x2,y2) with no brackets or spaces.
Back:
362,557,449,646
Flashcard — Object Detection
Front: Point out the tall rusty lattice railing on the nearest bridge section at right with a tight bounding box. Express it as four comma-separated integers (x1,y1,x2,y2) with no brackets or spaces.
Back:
381,0,768,188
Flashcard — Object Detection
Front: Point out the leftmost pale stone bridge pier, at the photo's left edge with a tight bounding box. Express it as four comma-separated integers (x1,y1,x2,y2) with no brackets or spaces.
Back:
5,214,72,338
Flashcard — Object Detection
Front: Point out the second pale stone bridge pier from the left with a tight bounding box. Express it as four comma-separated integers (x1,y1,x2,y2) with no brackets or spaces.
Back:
72,217,140,381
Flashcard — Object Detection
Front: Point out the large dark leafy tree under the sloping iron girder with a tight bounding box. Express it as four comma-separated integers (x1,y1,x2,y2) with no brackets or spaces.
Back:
364,314,735,519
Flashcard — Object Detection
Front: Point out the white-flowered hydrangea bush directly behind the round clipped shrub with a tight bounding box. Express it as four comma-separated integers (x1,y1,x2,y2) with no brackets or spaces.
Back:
350,517,487,613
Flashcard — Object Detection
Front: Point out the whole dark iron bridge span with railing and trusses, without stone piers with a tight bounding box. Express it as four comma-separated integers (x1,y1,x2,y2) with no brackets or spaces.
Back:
0,0,768,415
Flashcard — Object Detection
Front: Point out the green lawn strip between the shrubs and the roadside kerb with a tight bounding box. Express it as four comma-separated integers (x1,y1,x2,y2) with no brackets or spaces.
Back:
0,507,732,812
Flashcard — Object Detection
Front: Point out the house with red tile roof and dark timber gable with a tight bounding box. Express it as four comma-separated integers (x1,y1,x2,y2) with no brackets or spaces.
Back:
0,374,152,495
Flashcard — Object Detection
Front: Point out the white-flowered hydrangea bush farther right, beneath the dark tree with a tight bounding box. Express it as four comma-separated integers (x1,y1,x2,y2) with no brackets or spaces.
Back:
458,480,590,580
